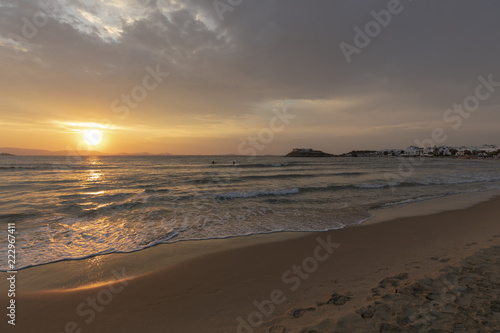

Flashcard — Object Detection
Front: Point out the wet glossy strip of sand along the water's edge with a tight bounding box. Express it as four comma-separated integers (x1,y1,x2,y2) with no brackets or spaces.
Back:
0,190,500,292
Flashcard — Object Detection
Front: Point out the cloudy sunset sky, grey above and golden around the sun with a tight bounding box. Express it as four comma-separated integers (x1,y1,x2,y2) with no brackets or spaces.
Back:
0,0,500,154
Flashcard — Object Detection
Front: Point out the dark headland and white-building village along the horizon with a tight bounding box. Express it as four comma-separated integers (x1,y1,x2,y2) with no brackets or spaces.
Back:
286,144,500,159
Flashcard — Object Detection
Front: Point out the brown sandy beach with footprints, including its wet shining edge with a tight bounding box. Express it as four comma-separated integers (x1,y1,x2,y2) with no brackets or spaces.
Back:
0,193,500,333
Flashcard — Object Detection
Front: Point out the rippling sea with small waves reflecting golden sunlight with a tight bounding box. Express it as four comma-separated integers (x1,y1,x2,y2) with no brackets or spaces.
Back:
0,156,500,270
